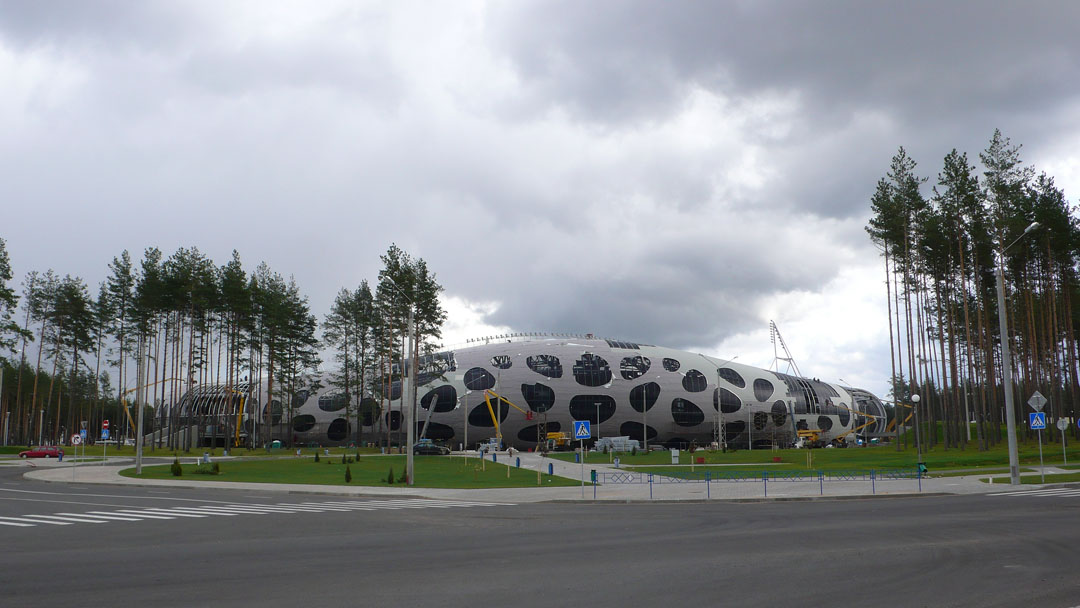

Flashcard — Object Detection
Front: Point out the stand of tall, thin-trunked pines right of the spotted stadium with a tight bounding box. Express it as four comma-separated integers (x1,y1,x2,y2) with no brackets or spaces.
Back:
866,130,1080,449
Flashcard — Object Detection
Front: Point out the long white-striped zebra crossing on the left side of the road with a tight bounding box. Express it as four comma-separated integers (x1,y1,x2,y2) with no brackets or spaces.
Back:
0,490,514,528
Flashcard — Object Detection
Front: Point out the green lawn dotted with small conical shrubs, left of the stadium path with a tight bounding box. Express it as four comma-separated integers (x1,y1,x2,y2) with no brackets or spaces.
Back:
120,454,580,488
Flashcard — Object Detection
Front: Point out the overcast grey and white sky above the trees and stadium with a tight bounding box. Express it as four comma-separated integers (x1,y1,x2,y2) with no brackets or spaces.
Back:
0,0,1080,396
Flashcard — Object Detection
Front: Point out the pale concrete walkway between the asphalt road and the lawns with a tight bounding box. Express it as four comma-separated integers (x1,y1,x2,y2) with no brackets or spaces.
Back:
10,452,1069,502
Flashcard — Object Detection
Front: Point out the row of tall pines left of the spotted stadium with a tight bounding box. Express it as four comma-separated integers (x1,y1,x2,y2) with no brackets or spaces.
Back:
0,239,446,449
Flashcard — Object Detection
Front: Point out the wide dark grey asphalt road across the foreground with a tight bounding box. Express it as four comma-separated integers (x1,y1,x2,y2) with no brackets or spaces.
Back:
0,460,1080,608
